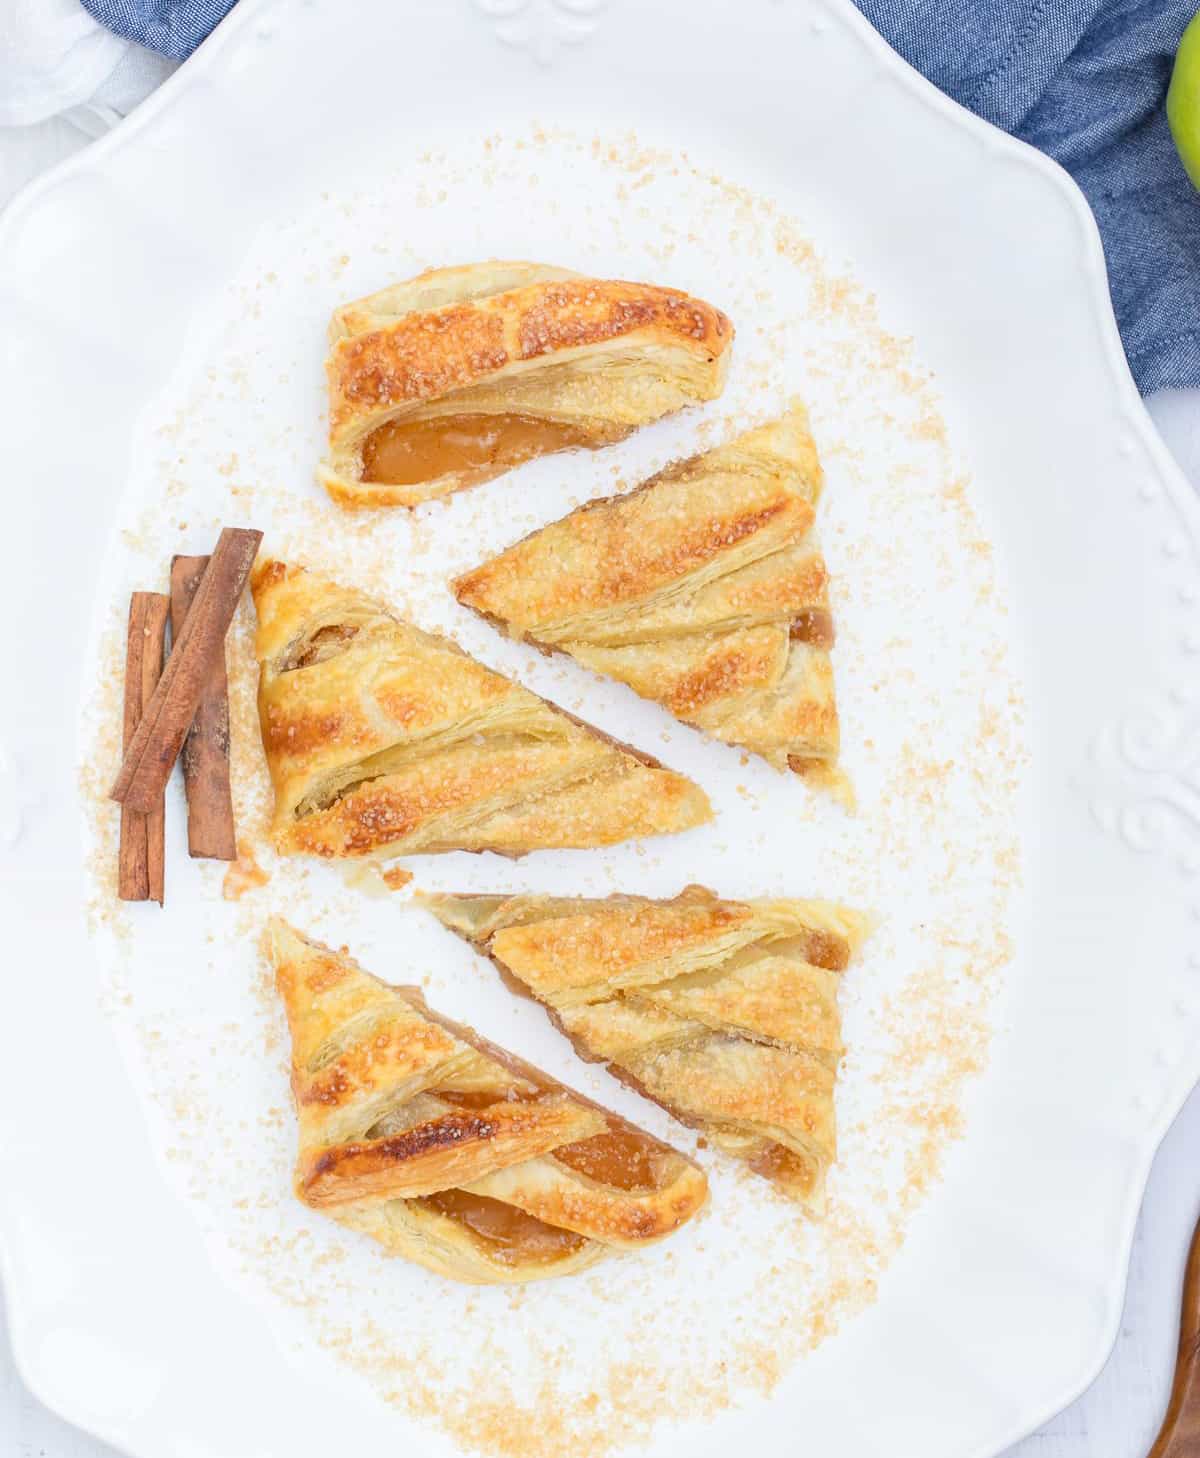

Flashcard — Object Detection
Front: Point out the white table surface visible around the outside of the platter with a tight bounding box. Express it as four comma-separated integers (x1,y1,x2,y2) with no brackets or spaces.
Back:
0,88,1200,1458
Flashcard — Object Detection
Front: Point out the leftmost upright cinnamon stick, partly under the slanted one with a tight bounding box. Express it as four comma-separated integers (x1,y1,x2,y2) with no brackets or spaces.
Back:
117,592,168,905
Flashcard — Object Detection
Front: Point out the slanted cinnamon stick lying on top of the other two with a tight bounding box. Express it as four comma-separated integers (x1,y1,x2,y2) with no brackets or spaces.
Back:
109,526,262,815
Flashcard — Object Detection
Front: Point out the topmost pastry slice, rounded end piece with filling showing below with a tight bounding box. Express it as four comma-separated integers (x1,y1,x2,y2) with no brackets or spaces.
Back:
318,262,733,506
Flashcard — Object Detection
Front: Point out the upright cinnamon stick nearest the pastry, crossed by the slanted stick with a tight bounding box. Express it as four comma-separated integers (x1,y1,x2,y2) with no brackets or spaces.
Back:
171,557,238,860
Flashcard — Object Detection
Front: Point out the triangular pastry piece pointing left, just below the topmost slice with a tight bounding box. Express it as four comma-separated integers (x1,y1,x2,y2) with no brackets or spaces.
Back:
455,405,850,802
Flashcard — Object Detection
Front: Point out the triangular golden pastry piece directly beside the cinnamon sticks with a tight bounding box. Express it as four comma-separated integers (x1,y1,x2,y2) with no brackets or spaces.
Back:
251,560,712,856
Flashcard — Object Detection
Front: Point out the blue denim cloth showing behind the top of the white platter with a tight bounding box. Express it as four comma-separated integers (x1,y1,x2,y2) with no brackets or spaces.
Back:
83,0,1200,394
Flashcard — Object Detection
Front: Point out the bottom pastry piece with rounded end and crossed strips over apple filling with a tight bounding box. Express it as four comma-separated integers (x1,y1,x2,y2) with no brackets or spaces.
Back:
268,917,707,1283
